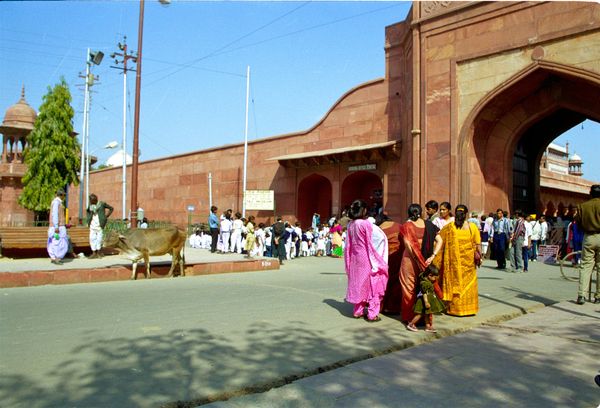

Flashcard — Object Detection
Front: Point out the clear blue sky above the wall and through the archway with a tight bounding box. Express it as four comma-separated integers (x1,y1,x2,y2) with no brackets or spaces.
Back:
0,0,600,180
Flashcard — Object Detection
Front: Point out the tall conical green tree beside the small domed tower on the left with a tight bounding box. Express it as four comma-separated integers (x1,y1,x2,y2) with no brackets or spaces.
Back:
19,78,81,216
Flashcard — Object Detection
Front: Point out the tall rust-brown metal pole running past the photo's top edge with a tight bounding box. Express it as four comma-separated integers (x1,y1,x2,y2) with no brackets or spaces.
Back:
131,0,144,228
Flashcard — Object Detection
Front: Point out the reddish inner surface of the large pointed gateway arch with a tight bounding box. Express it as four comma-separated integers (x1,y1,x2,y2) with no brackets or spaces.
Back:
460,61,600,212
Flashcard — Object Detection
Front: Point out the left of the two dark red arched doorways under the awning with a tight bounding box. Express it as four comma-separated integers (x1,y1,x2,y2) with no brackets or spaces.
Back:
297,174,332,229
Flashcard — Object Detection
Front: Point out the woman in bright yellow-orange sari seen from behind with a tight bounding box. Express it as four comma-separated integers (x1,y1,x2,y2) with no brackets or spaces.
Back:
433,204,481,316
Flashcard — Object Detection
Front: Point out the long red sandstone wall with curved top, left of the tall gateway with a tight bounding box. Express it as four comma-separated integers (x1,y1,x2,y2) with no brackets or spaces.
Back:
70,79,397,226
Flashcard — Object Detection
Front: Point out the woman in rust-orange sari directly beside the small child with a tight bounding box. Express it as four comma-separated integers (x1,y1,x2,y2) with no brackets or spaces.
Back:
400,204,442,322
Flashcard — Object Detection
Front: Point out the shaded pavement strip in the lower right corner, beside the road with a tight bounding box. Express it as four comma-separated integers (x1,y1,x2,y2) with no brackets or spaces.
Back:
205,302,600,408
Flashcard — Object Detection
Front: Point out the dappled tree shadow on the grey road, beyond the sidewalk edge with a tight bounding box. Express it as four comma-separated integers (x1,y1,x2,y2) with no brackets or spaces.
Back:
0,318,408,408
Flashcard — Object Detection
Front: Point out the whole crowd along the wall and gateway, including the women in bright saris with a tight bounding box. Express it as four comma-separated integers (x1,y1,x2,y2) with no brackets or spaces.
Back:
190,186,600,326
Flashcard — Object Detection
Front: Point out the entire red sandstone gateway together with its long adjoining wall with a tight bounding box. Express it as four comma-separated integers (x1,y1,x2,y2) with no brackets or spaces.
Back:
0,1,600,226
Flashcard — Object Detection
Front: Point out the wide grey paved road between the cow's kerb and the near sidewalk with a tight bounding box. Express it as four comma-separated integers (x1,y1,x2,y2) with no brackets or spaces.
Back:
0,258,597,407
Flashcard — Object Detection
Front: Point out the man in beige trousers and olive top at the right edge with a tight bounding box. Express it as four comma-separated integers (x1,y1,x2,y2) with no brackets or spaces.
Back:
575,184,600,305
